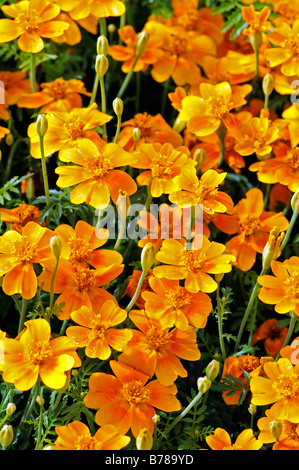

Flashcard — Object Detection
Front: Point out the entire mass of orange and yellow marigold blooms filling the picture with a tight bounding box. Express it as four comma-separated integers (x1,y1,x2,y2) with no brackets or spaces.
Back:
0,0,299,450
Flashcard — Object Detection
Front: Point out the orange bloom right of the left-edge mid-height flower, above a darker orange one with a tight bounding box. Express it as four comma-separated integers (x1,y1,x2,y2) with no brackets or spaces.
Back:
55,220,118,268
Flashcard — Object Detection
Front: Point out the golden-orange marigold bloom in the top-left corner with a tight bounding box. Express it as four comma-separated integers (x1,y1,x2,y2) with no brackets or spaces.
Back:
0,0,69,53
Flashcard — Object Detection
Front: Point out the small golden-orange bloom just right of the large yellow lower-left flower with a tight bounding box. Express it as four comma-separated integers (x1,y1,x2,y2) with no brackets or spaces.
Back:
66,300,132,361
